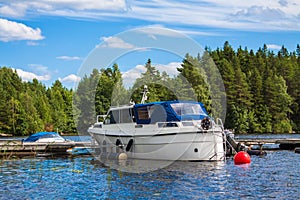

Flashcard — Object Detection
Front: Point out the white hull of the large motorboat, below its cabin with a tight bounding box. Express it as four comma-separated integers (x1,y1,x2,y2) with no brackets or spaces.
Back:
89,125,225,161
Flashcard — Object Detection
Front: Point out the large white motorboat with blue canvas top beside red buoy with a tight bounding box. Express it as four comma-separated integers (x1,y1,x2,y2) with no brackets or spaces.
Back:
88,87,226,161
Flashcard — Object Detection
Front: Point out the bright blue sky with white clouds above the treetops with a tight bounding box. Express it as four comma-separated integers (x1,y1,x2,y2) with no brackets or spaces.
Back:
0,0,300,87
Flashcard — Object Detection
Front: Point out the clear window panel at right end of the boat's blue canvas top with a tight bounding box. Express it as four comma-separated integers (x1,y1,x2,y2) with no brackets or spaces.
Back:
170,103,205,116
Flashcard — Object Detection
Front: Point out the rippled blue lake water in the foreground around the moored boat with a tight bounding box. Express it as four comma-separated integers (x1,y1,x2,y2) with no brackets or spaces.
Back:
0,135,300,199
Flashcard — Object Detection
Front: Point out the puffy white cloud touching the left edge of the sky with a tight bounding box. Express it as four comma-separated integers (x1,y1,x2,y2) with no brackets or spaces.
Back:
0,18,44,42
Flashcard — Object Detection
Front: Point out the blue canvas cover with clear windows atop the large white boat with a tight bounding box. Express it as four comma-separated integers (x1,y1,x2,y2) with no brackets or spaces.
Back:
134,101,208,124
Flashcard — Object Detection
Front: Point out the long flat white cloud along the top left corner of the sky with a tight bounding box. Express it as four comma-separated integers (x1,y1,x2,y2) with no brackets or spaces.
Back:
0,0,128,17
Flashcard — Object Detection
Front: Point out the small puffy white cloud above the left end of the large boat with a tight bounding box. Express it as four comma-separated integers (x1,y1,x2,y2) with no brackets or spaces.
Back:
98,36,135,49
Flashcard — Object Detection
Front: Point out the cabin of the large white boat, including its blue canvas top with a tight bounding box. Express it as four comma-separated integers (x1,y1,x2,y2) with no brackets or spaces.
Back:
104,101,208,124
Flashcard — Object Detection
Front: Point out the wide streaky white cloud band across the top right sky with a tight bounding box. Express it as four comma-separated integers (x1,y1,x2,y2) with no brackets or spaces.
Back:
127,0,300,31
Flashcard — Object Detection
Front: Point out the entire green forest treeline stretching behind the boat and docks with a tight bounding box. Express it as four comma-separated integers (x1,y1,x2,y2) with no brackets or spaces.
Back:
0,42,300,135
